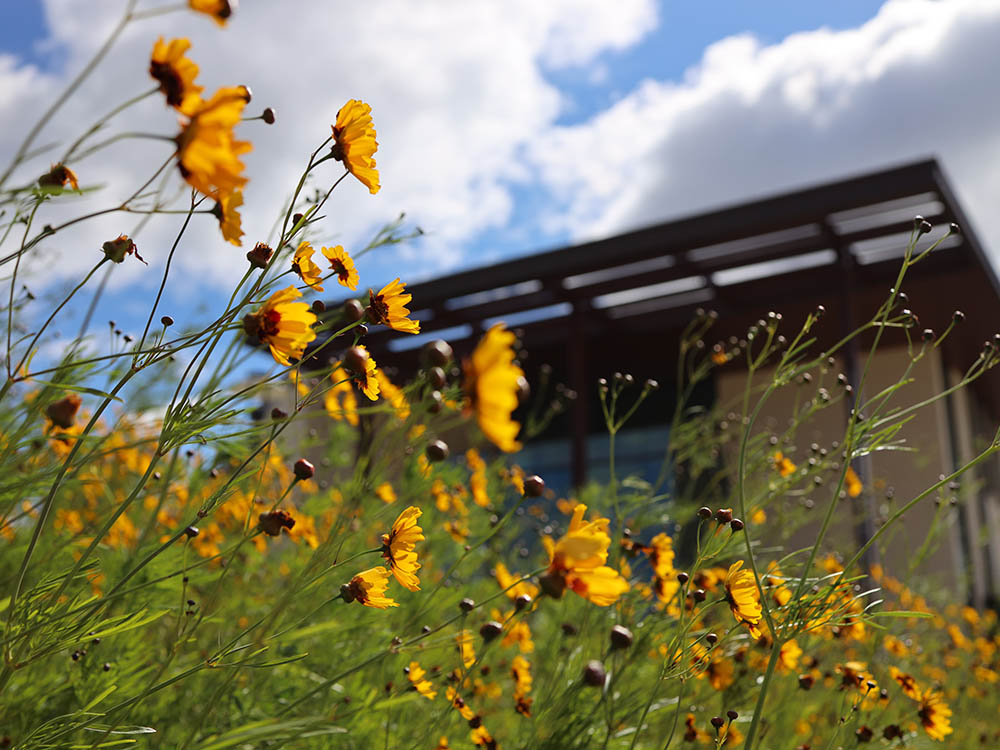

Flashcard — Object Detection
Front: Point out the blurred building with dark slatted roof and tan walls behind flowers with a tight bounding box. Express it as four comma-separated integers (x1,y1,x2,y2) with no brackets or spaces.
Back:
324,161,1000,605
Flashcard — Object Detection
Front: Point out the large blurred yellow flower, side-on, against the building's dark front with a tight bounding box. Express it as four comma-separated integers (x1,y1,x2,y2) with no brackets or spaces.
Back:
463,323,524,453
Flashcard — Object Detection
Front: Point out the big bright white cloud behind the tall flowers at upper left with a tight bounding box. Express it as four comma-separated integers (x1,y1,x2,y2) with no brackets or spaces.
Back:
0,0,656,292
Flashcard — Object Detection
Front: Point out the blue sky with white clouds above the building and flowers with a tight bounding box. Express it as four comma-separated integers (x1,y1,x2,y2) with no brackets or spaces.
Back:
0,0,1000,356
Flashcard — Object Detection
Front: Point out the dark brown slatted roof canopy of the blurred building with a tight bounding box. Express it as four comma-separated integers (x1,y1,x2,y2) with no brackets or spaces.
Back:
318,160,1000,488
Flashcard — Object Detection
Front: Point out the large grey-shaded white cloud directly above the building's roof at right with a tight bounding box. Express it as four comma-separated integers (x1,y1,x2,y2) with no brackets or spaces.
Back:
532,0,1000,264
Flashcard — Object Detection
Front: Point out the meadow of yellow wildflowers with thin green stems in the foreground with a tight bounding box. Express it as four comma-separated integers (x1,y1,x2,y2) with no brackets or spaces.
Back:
0,0,1000,750
